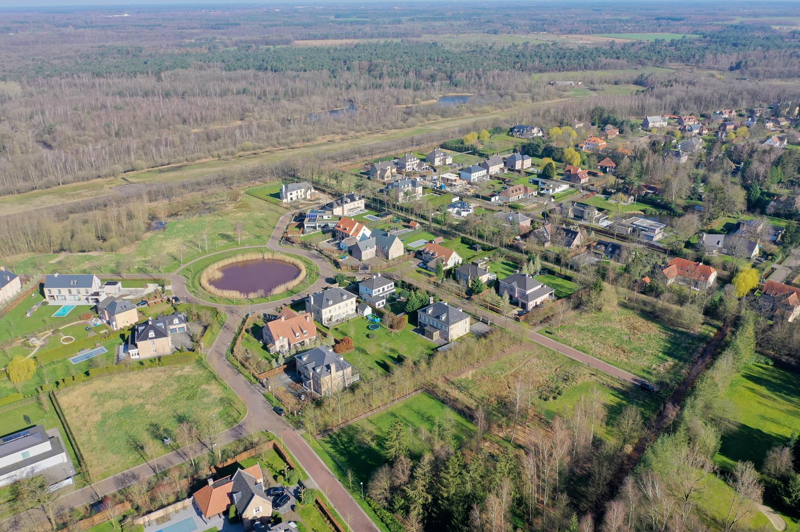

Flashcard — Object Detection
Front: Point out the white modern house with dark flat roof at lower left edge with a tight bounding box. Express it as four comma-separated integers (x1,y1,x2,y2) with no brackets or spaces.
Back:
0,425,69,488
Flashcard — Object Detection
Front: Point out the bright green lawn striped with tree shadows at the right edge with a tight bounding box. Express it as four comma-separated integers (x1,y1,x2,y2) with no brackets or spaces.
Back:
715,364,800,469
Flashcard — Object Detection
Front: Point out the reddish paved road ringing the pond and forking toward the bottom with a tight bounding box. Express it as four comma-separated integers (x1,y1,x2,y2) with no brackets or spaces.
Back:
45,207,378,532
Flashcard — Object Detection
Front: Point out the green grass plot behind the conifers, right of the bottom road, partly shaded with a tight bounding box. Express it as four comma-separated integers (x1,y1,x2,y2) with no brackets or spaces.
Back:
319,393,475,484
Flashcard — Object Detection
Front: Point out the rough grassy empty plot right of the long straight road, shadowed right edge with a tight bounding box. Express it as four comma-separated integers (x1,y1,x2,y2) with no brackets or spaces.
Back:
544,307,713,382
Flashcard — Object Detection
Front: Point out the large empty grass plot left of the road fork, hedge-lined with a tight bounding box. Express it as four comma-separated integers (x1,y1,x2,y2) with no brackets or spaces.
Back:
58,361,246,480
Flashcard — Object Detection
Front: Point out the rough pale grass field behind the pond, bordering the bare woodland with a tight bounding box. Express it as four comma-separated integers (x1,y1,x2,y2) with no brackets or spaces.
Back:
3,195,282,274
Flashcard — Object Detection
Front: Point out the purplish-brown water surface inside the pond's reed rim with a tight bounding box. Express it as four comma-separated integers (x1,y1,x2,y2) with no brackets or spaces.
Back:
209,259,300,295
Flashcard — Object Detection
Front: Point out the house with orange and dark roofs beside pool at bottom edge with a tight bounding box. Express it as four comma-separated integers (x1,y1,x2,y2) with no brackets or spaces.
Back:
192,463,272,530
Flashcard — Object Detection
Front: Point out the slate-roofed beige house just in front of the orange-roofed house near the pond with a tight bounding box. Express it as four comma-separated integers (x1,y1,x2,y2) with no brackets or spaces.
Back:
295,345,360,396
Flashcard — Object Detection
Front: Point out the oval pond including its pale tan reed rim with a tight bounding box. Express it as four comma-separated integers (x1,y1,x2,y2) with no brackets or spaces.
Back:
203,258,304,298
